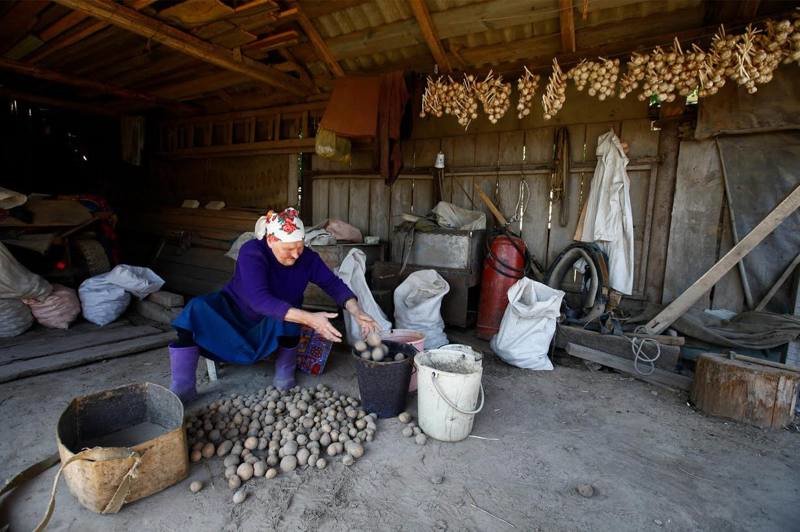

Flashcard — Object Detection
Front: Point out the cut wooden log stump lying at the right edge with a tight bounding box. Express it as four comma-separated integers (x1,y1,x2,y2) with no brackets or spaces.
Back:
691,353,800,429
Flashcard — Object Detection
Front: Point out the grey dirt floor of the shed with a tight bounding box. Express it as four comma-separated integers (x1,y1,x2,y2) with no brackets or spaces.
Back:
0,332,800,531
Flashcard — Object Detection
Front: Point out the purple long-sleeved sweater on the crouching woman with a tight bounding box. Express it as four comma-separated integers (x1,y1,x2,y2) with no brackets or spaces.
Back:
223,240,355,321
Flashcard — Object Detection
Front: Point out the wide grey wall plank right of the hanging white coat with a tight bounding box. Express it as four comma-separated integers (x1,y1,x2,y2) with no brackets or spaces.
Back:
663,140,723,309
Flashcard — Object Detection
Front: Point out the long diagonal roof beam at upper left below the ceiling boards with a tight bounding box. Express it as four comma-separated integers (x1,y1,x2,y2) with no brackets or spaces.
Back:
57,0,310,96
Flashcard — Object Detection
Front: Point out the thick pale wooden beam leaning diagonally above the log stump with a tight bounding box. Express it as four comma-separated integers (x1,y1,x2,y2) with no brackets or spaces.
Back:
644,186,800,334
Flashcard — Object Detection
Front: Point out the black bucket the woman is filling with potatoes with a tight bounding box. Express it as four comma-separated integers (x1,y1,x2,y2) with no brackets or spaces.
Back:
352,340,417,418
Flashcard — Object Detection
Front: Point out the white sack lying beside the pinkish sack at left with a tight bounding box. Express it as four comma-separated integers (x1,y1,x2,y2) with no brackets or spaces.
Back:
78,264,164,327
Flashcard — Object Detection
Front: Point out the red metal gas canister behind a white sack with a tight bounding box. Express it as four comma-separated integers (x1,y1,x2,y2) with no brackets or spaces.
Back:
475,235,525,340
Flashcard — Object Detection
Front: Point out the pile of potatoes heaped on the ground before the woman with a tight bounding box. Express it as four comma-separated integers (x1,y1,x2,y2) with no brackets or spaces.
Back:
186,384,377,490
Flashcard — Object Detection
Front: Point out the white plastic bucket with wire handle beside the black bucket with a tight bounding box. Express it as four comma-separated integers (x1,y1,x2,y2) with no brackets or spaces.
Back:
414,349,484,441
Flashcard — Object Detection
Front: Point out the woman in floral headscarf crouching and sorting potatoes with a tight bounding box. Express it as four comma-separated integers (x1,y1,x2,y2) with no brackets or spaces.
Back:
169,208,378,402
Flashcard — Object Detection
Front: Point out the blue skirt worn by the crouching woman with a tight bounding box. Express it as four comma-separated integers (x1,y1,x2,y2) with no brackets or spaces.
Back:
172,292,300,364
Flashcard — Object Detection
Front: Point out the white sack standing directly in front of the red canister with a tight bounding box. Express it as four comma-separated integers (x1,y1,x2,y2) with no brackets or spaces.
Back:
489,277,564,370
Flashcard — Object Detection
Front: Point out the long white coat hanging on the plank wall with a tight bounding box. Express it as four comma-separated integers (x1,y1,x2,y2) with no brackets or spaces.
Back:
575,131,633,295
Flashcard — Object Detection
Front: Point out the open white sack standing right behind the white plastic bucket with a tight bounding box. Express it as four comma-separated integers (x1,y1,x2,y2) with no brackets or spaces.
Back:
394,270,450,349
